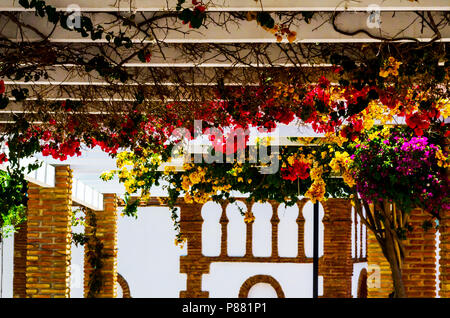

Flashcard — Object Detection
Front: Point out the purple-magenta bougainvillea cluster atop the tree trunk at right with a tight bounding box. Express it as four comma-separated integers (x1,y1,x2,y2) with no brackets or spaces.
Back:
352,129,450,215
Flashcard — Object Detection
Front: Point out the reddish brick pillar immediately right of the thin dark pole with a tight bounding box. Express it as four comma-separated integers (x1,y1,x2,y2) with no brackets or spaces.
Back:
319,199,353,298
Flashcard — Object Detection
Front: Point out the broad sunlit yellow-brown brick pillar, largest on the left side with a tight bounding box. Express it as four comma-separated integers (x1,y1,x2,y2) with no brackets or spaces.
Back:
26,166,72,298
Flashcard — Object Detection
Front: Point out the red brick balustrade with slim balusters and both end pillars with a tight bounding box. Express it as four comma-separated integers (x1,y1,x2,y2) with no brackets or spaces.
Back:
179,199,353,298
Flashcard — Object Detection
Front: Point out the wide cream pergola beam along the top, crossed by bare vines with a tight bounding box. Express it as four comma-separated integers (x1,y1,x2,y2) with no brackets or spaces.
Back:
0,12,450,43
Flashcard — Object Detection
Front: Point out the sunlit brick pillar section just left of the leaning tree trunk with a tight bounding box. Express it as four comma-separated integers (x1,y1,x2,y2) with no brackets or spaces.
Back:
367,229,394,298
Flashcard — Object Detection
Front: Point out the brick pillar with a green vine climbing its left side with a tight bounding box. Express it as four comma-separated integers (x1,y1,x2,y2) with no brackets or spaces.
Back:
84,193,117,298
